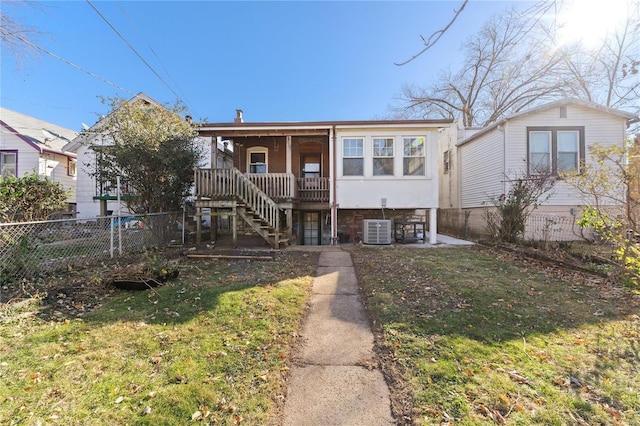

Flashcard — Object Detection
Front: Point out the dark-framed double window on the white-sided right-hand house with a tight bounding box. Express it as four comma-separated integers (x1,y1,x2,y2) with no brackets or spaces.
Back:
528,127,585,174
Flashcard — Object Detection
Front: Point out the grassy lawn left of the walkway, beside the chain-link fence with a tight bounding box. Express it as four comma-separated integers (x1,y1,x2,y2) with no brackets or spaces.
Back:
0,253,317,425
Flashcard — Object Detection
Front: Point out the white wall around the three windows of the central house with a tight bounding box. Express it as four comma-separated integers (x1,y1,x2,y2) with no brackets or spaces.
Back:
336,127,438,209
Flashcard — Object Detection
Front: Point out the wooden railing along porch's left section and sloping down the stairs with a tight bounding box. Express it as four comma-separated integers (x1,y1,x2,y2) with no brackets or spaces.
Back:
195,168,280,234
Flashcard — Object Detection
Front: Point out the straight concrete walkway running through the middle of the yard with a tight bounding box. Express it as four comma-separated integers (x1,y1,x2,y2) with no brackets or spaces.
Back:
284,247,394,426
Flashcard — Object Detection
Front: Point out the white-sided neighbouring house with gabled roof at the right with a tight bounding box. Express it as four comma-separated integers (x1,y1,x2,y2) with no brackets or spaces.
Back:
439,99,638,239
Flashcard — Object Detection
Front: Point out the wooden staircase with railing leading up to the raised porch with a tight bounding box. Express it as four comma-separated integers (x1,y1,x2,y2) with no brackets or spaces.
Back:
196,168,289,249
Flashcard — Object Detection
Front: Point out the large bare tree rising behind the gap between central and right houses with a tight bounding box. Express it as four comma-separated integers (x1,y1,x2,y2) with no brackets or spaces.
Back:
401,3,568,127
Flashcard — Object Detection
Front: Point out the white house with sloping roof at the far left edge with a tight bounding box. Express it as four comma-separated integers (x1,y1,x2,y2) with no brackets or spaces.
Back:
0,107,77,214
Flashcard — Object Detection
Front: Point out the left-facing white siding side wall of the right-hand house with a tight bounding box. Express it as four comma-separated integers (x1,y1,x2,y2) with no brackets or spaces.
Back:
458,129,505,208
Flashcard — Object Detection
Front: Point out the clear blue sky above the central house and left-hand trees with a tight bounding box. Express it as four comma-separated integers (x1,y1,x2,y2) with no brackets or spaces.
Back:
0,0,525,131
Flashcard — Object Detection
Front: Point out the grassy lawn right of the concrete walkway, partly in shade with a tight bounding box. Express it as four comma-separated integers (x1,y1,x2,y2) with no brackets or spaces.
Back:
352,246,640,425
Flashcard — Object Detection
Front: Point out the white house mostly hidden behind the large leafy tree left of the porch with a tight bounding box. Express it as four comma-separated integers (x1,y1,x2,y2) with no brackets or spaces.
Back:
65,93,225,219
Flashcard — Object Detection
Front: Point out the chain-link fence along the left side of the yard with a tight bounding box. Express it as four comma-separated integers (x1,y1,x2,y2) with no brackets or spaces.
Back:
0,212,185,282
